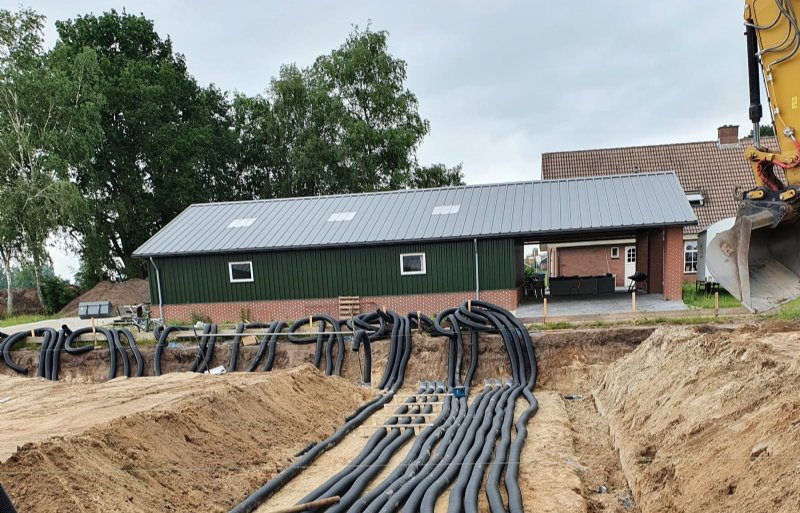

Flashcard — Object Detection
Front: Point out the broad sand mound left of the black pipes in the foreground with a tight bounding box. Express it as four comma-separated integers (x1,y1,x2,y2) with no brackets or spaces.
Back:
0,365,372,513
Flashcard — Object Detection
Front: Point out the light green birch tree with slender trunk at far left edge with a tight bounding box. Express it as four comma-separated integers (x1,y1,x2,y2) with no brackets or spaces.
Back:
0,9,100,307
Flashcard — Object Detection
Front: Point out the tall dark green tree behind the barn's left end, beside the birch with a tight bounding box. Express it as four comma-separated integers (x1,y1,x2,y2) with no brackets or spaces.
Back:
56,10,238,278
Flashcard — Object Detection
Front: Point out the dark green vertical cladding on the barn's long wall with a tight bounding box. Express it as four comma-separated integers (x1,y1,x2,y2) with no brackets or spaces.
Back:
150,239,523,304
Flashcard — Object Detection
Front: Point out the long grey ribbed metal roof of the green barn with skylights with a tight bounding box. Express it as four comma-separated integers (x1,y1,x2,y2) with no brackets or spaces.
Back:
134,173,697,257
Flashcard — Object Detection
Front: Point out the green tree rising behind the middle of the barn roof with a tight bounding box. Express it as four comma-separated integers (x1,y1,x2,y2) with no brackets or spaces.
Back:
233,28,463,198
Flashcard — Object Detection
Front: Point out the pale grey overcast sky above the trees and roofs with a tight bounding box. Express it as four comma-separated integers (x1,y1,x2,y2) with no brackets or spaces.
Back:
31,0,749,276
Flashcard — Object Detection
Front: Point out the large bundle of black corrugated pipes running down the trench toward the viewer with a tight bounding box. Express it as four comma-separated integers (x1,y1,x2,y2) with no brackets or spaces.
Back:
225,301,538,513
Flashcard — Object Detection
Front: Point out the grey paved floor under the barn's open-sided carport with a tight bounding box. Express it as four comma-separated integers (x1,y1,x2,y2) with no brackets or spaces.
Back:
516,292,689,318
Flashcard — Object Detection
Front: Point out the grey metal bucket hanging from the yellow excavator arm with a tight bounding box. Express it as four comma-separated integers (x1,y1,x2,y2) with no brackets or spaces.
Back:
706,200,800,312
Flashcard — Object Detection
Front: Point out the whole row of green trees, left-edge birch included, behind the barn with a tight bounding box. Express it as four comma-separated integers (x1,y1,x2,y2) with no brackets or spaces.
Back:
0,9,462,286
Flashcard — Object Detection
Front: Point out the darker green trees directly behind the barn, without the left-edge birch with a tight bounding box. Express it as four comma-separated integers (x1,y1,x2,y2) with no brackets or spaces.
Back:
37,10,462,283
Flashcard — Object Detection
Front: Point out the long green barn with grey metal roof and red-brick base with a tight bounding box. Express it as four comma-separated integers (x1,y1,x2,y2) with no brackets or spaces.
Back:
135,173,693,321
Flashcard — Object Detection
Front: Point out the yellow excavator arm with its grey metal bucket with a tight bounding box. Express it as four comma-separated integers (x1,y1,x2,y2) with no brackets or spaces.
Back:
706,0,800,312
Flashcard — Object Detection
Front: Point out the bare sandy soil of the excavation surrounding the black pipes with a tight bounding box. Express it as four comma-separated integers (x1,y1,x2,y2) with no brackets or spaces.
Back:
0,323,800,513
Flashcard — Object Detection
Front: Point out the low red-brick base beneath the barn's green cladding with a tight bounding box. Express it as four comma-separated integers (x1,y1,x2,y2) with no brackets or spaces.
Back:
153,289,521,322
